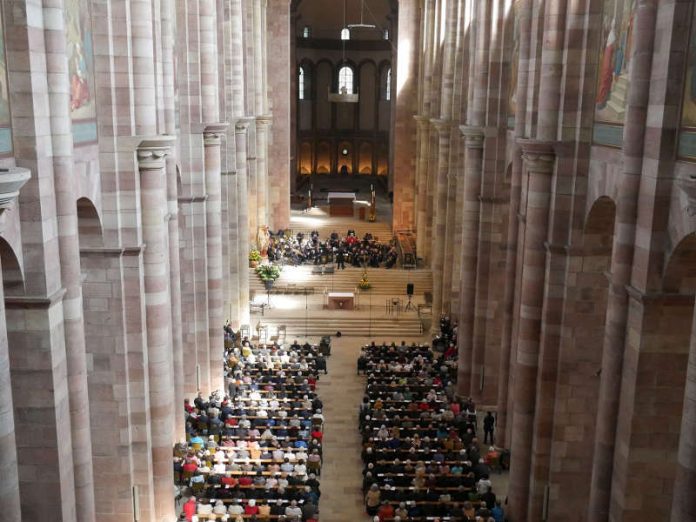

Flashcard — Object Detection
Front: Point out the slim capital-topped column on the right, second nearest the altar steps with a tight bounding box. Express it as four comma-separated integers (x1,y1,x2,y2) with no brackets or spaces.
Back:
431,120,452,320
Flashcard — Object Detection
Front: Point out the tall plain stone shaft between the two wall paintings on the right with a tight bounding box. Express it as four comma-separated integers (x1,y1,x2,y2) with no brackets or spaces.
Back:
588,2,659,522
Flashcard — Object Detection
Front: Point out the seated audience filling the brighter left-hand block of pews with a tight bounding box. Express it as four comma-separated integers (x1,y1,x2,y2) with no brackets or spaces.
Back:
174,338,326,522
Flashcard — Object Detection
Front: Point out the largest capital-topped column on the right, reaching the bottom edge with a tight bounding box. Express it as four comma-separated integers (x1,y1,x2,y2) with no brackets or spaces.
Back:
508,140,555,522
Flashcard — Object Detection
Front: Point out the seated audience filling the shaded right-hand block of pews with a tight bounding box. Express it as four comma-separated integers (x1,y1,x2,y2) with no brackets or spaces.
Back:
358,332,505,522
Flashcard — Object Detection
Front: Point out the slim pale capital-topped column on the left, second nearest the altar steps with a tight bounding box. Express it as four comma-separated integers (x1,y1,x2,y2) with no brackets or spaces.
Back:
234,118,251,324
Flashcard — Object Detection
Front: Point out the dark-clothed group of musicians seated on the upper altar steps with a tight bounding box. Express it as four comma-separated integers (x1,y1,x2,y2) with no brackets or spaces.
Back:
267,230,398,269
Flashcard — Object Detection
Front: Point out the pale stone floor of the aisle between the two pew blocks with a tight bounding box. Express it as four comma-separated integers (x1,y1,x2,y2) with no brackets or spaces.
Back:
317,336,430,522
